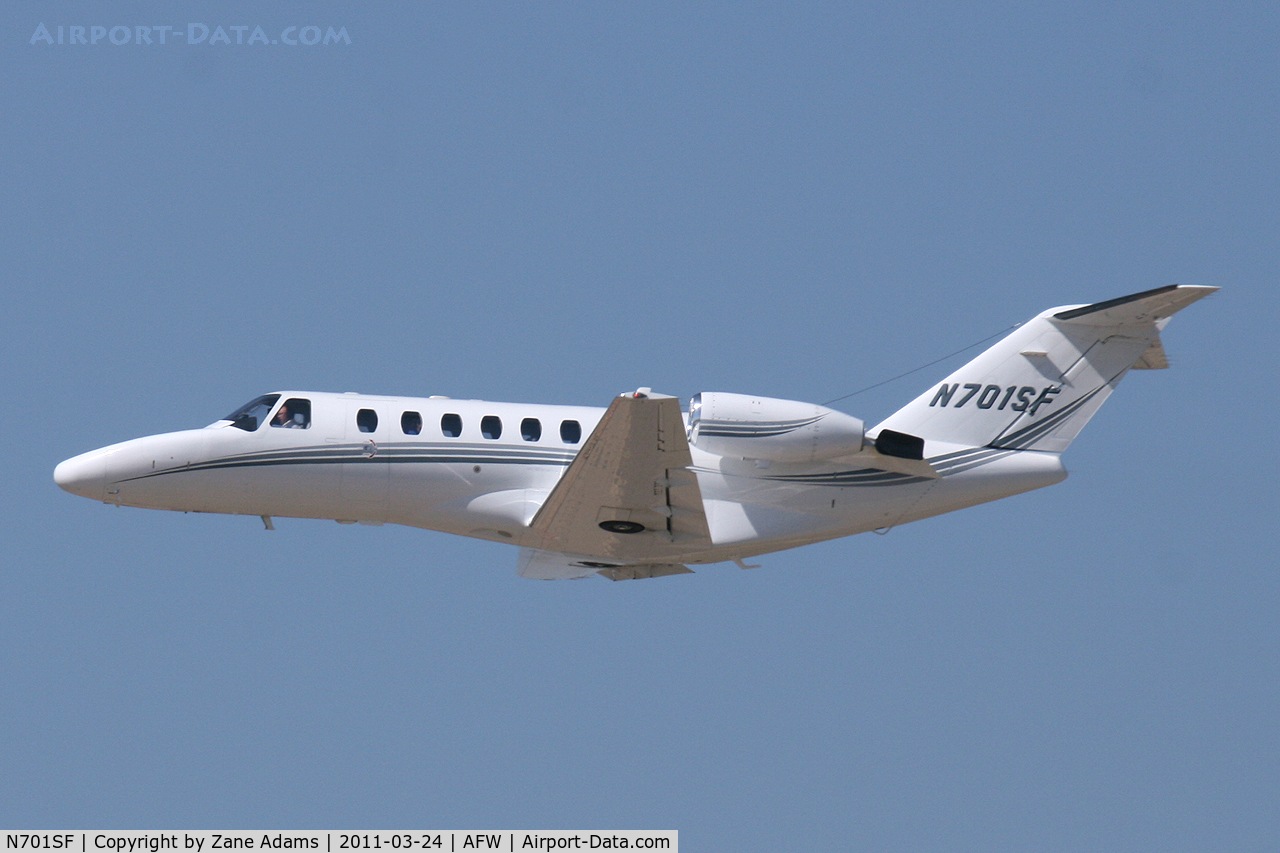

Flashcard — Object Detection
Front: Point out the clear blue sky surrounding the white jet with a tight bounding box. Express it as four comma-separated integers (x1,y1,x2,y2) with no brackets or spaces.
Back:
0,3,1280,850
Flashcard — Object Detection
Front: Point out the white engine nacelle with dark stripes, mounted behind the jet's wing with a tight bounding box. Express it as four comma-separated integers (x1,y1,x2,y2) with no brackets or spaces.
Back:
689,391,864,462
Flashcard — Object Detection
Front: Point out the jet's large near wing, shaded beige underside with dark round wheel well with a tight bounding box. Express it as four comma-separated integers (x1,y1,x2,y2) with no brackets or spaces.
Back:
530,388,710,560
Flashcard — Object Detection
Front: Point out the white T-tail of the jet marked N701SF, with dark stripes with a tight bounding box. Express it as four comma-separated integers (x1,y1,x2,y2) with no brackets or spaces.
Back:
879,284,1217,453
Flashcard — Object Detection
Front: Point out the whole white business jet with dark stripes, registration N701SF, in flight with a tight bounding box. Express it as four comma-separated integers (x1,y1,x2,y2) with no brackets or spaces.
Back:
54,284,1217,580
